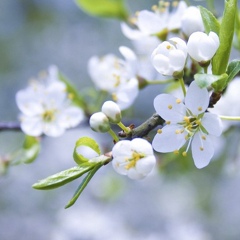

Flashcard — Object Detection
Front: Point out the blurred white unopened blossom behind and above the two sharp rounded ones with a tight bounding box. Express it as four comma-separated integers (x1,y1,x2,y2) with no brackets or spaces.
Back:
181,6,204,37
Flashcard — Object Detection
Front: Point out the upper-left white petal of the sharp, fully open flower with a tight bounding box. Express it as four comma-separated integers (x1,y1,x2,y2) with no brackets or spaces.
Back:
153,94,186,123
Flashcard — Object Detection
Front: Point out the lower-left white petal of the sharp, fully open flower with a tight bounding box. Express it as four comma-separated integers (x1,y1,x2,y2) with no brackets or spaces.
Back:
152,125,187,153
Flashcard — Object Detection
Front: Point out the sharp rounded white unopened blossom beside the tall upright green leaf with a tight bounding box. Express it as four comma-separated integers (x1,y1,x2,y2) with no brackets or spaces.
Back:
187,32,220,63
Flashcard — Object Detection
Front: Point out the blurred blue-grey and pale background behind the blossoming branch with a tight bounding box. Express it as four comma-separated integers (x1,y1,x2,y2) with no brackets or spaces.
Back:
0,0,240,240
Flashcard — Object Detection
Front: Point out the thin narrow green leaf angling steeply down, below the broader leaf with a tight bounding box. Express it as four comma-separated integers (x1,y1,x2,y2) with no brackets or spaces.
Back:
65,163,103,208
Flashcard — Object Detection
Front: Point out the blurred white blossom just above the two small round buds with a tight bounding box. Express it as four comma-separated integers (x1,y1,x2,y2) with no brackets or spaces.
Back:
88,46,139,109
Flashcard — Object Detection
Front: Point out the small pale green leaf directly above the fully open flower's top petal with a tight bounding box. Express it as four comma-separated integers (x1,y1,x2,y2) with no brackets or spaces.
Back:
194,73,228,88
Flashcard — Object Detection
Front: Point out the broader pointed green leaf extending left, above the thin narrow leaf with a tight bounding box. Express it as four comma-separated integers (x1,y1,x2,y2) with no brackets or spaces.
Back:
32,163,96,190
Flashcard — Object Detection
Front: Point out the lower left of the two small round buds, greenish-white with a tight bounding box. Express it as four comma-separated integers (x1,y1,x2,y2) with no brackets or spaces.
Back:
89,112,110,132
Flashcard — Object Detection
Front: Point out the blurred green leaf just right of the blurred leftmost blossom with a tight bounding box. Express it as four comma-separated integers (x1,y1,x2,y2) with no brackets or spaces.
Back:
58,73,87,111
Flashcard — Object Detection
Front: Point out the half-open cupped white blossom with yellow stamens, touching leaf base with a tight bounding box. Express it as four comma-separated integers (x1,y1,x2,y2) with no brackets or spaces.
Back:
112,138,156,179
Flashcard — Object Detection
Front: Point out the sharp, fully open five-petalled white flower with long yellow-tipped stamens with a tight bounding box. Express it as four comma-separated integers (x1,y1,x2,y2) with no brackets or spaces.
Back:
152,82,222,168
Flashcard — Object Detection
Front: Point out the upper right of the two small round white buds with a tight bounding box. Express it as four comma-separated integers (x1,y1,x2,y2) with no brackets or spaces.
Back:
102,101,122,123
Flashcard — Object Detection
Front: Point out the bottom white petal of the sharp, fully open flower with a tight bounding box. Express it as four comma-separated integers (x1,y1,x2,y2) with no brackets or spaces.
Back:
192,132,214,168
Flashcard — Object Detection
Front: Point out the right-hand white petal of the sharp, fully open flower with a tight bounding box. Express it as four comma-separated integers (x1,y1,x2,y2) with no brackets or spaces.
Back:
201,113,222,136
